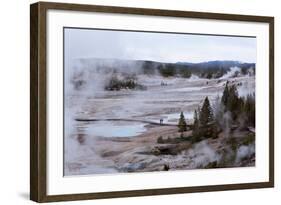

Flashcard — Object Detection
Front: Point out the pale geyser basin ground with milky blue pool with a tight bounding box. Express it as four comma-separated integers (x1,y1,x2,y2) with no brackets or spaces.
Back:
65,76,255,176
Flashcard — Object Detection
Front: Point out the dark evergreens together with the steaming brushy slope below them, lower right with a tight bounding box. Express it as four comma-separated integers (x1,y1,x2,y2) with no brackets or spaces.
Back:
152,77,255,168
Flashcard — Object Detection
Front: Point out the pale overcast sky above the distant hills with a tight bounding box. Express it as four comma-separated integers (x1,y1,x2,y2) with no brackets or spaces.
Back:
65,28,256,63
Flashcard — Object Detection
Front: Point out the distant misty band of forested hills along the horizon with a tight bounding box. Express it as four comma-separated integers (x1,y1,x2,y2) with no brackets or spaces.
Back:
70,58,255,91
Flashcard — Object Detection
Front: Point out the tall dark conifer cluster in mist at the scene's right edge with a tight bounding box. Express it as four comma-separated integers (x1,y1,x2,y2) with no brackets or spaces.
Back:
192,82,255,141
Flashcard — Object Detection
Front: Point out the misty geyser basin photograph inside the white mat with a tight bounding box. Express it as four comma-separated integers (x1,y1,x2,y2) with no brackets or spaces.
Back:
63,27,257,176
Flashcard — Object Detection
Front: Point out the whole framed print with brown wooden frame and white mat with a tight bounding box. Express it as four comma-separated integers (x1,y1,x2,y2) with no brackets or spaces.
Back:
30,2,274,202
